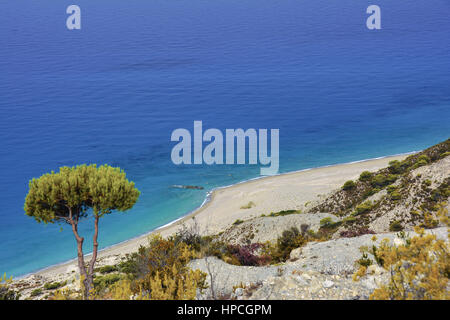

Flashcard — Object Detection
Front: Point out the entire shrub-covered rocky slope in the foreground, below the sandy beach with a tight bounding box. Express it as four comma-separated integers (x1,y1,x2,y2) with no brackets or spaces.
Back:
8,140,450,300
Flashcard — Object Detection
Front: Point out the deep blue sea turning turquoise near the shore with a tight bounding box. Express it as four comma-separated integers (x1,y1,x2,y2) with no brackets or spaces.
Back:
0,0,450,276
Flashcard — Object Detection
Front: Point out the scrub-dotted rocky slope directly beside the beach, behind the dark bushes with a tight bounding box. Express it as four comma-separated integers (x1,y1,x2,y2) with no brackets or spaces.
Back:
214,140,450,245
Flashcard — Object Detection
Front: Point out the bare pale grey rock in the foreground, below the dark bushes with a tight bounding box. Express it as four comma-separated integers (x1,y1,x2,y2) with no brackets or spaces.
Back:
190,228,448,300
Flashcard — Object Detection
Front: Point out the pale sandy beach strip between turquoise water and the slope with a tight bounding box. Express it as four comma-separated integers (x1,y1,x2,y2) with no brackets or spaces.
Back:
28,153,412,279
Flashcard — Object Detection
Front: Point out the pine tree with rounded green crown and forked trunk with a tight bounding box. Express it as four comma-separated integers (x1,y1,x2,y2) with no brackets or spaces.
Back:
24,164,139,298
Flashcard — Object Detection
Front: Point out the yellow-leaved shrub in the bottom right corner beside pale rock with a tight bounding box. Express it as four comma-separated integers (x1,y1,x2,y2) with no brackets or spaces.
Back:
354,206,450,300
